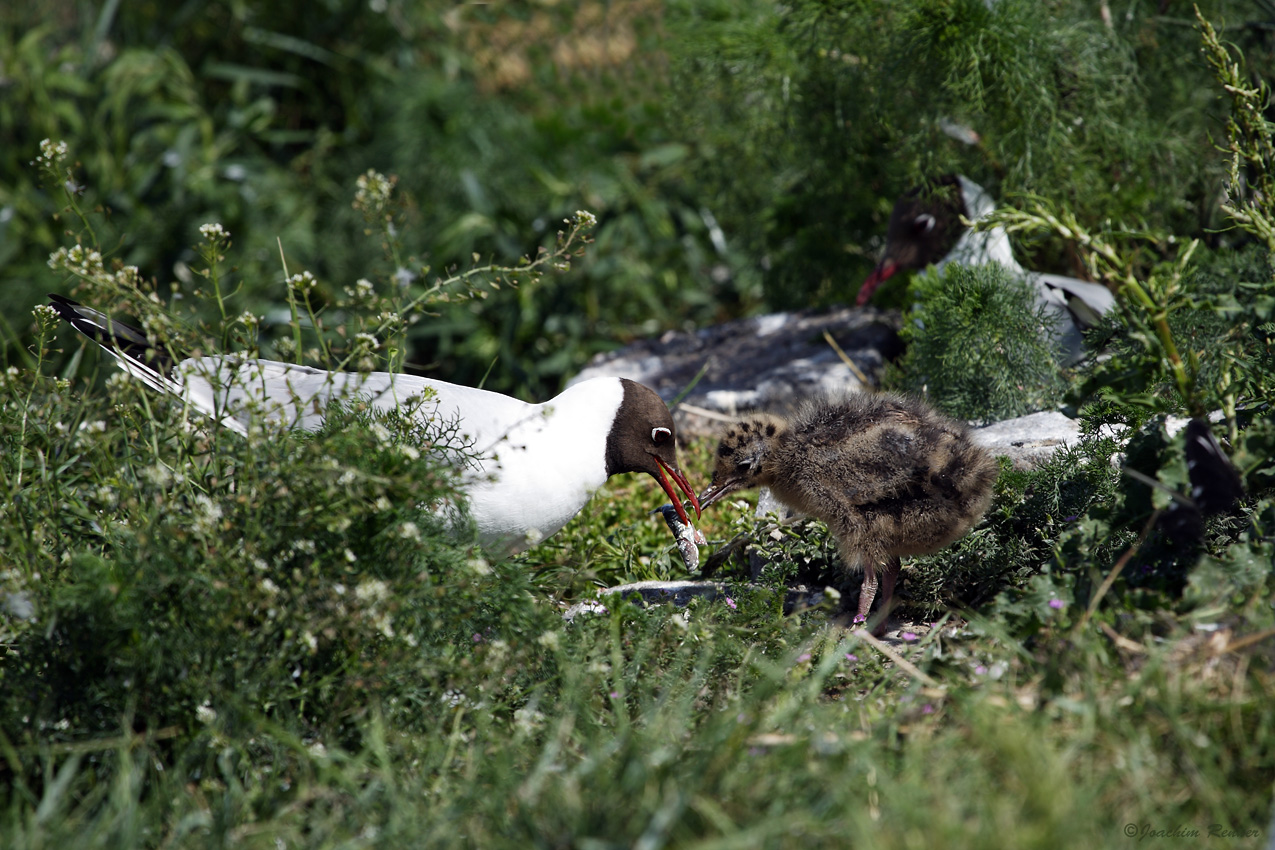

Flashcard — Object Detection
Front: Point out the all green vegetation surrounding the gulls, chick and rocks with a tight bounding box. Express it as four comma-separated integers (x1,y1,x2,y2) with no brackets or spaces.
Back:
0,0,1275,850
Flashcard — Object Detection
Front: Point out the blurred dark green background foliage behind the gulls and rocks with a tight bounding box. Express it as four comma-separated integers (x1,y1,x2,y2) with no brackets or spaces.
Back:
7,0,1272,395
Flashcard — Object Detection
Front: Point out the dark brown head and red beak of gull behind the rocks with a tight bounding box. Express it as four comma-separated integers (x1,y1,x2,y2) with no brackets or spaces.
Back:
854,175,970,307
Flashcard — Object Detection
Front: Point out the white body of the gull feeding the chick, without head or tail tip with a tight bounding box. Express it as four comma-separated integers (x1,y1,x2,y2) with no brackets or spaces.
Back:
177,357,623,553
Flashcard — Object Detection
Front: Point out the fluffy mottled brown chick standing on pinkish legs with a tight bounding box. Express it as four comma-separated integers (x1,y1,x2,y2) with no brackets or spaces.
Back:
700,394,997,635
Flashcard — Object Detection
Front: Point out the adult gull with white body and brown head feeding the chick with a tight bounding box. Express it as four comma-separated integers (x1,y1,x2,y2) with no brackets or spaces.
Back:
48,294,700,553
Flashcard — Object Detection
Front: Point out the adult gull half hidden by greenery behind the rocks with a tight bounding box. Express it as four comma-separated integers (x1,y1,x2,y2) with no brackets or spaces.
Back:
854,175,1116,362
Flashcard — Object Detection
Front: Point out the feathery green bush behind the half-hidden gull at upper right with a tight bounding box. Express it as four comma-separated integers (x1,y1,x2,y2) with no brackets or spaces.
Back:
674,0,1272,307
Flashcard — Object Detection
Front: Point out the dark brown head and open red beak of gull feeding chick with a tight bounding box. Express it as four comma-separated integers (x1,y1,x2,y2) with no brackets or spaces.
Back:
607,378,700,525
